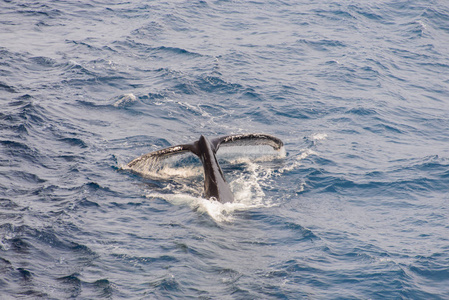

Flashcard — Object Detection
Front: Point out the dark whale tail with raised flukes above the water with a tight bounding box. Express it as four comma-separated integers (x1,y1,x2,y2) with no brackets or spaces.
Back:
127,133,284,203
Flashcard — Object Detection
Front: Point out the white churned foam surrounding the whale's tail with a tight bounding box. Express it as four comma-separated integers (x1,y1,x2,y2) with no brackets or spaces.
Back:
134,146,308,222
